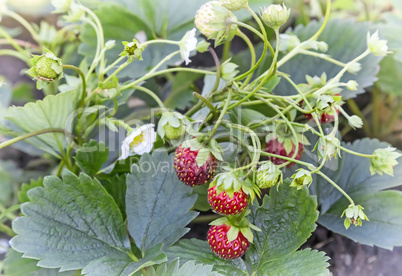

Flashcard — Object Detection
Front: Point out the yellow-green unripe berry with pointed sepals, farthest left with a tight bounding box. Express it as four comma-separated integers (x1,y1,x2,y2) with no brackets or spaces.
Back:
26,48,63,89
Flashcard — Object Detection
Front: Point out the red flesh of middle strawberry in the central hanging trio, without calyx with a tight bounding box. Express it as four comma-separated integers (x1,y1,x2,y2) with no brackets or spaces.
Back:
208,186,248,216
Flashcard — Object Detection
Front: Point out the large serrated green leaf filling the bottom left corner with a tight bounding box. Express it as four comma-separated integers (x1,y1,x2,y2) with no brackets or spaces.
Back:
10,172,130,275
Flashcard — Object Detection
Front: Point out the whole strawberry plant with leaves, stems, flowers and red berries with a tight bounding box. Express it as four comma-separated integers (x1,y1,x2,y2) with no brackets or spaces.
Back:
0,0,402,276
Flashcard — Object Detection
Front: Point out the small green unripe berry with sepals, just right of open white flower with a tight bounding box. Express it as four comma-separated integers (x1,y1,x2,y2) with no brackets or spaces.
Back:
157,111,190,140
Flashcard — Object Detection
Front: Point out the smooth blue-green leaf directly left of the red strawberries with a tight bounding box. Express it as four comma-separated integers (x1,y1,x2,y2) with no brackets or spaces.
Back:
126,151,198,251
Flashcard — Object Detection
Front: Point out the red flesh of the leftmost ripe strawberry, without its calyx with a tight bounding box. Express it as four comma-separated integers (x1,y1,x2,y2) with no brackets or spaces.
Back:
173,145,218,187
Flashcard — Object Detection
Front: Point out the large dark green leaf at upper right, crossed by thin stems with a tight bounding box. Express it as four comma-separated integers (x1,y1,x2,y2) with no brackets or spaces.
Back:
275,19,381,99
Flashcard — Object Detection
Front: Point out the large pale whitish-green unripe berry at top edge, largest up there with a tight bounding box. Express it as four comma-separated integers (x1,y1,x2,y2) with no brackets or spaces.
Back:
194,1,237,46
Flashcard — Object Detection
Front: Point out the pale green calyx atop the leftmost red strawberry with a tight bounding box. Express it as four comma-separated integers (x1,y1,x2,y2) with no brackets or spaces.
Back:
181,136,223,167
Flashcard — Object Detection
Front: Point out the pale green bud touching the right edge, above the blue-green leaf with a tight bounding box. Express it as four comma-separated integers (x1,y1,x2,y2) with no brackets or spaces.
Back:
370,147,402,176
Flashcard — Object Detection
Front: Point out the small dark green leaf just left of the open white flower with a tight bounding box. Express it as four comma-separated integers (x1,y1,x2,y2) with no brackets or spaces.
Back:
75,140,109,176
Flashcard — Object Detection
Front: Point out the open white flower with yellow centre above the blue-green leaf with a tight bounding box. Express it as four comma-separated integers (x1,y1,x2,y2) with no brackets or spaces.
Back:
119,124,156,159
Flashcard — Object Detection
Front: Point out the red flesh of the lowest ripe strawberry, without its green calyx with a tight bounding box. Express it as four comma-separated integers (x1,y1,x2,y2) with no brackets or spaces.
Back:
208,224,250,259
